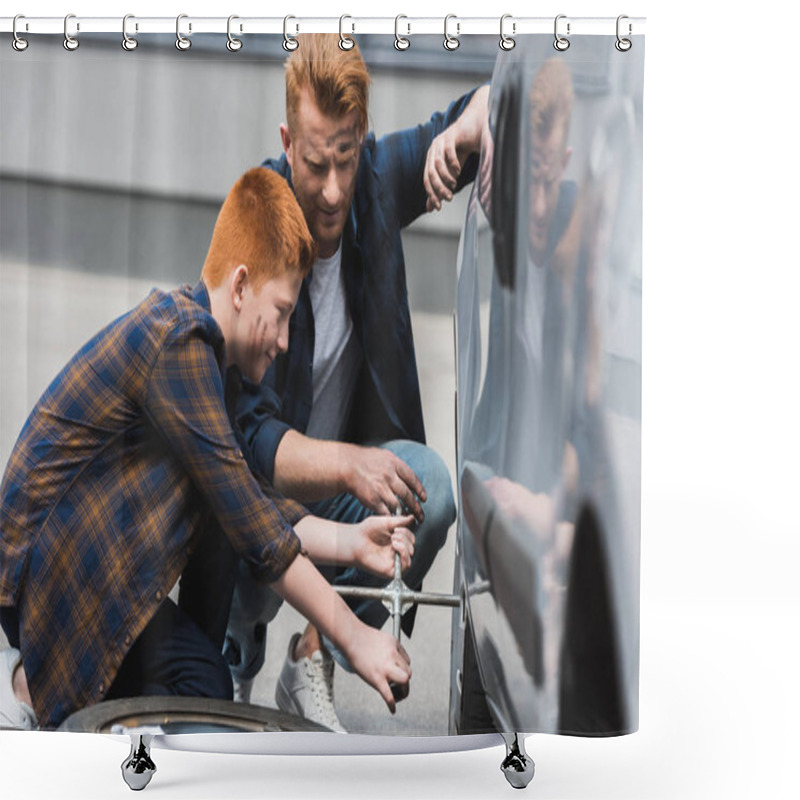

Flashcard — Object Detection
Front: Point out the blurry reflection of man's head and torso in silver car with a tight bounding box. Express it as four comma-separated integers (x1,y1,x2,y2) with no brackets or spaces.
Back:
465,59,576,492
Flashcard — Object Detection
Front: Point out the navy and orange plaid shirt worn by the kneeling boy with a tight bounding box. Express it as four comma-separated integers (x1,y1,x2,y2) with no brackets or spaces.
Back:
0,283,306,728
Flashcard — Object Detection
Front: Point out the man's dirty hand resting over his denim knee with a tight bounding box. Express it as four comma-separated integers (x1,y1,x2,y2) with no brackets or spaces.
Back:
347,445,428,522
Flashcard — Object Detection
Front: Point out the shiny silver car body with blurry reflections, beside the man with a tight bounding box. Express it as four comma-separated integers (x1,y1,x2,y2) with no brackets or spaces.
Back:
450,40,641,735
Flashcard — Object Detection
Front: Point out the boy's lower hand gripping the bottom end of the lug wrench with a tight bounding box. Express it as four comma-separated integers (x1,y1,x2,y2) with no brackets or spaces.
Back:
345,624,411,714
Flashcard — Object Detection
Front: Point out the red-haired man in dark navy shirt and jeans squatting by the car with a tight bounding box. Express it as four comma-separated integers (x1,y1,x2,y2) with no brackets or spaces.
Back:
226,35,488,727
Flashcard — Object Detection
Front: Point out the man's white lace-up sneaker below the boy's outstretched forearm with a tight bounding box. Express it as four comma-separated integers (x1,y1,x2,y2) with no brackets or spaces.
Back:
275,633,346,733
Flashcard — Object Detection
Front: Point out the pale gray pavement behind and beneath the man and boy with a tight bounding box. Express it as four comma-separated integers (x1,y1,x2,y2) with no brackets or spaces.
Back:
0,259,455,735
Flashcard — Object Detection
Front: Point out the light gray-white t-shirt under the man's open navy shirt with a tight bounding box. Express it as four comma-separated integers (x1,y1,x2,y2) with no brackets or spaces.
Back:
306,241,361,439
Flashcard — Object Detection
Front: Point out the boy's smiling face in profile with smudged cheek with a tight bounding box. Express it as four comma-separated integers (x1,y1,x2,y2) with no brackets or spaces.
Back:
226,272,302,383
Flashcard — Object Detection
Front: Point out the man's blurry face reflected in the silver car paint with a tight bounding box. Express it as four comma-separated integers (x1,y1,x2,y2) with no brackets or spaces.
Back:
528,125,570,265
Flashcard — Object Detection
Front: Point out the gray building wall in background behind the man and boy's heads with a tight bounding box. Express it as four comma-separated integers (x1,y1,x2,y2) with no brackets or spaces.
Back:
0,37,492,311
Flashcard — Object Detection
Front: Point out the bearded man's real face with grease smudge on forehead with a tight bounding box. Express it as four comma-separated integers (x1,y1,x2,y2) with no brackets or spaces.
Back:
281,90,361,258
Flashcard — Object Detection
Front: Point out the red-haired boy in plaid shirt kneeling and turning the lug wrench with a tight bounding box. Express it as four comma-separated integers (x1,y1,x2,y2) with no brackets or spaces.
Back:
0,168,413,728
